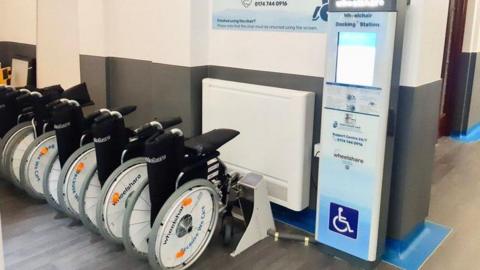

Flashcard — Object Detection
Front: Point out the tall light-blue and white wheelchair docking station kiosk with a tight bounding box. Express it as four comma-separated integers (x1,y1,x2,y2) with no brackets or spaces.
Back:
316,0,397,262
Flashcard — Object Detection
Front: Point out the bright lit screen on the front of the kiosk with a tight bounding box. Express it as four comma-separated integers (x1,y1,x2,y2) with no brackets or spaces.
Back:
337,32,377,86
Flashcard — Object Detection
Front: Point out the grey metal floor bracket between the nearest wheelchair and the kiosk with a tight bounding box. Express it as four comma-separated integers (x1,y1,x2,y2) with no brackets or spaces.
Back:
230,173,275,257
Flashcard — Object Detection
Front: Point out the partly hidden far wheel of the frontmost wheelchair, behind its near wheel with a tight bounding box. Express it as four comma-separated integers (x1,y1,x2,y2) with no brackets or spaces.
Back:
122,178,152,258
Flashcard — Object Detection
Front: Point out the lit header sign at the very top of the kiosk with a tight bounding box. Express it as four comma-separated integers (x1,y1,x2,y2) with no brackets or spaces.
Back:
328,0,397,12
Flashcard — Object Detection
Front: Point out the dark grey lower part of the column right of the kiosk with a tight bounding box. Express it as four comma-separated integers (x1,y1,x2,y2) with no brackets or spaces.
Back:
388,81,442,239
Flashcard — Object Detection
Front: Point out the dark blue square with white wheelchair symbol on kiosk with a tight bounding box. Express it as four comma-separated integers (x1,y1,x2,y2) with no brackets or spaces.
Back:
329,203,358,239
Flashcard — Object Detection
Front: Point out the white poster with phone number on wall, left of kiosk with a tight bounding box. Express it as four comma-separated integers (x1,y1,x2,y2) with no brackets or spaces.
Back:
212,0,328,33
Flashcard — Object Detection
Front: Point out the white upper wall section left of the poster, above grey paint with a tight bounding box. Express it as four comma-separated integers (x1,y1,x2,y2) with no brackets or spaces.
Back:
78,0,208,66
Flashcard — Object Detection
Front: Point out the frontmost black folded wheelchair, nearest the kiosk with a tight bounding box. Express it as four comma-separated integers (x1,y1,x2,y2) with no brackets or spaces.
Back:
123,129,239,269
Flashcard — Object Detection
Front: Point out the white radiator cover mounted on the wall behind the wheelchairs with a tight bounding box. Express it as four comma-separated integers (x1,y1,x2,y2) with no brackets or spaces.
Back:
202,79,315,211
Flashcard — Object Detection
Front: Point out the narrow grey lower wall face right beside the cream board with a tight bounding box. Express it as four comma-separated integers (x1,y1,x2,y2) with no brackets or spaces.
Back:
80,55,107,112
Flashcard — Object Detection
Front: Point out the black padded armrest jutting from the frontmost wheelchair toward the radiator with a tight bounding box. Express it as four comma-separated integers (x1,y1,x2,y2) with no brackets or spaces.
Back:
185,129,240,155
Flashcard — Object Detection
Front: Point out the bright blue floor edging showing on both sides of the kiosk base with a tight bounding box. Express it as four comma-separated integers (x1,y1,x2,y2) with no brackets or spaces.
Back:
272,204,452,270
